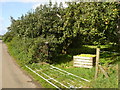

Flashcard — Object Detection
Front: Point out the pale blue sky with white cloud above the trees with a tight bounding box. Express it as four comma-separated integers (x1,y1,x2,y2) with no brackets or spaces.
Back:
0,0,70,35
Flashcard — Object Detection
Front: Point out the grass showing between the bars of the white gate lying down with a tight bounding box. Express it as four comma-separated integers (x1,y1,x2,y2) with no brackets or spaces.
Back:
27,65,90,88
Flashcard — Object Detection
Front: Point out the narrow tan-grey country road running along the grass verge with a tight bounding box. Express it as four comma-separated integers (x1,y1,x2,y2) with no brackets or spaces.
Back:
0,40,38,88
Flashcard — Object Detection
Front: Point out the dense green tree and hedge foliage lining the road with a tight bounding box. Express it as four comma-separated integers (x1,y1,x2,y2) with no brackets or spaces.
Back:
4,2,119,63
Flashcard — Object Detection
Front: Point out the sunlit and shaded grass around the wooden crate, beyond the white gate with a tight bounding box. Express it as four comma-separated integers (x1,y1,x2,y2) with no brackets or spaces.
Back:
51,45,120,88
